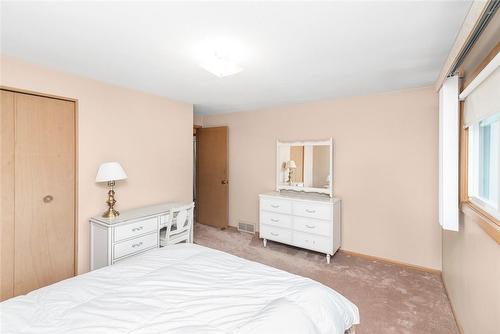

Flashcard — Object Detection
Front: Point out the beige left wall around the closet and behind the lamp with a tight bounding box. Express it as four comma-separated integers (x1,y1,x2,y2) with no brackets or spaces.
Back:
0,57,193,273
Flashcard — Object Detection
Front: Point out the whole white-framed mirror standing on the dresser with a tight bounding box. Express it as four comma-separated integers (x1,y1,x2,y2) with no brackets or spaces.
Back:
276,138,333,196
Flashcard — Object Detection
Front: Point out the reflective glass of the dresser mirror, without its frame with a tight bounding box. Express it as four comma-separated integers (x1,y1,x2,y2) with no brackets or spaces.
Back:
278,145,332,188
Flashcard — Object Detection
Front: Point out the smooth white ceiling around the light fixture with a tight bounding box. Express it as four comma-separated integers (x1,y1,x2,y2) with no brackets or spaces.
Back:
1,1,471,114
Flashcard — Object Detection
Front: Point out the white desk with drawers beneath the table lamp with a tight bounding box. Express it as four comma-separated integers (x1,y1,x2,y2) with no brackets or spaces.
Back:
90,202,193,270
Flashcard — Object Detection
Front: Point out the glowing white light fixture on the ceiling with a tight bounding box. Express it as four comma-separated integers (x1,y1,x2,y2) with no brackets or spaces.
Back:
195,38,247,78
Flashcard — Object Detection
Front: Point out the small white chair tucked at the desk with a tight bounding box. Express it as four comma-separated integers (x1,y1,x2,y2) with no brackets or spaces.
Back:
160,204,193,247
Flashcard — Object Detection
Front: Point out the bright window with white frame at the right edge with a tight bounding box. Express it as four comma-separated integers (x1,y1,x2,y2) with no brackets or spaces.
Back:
469,112,500,219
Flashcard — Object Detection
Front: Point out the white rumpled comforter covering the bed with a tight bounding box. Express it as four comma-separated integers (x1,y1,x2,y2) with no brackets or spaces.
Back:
0,244,359,334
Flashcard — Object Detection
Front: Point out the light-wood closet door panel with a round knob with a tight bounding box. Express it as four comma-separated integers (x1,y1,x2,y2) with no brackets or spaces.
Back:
14,93,75,295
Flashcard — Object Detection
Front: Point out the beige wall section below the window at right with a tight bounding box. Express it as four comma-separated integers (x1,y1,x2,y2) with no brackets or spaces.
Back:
443,214,500,334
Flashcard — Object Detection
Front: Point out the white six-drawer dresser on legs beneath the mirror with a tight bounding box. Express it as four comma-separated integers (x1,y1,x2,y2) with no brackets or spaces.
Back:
259,192,341,263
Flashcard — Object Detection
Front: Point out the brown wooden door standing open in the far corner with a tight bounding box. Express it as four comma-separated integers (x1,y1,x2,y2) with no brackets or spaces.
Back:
196,126,229,228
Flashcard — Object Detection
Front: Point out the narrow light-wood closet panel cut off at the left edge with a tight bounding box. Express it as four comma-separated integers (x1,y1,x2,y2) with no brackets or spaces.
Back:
0,90,14,301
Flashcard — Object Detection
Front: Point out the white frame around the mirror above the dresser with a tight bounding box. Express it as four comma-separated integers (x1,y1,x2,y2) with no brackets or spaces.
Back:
276,138,334,197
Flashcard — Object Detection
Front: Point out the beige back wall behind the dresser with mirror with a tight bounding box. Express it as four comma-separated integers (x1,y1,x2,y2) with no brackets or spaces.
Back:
203,87,441,269
